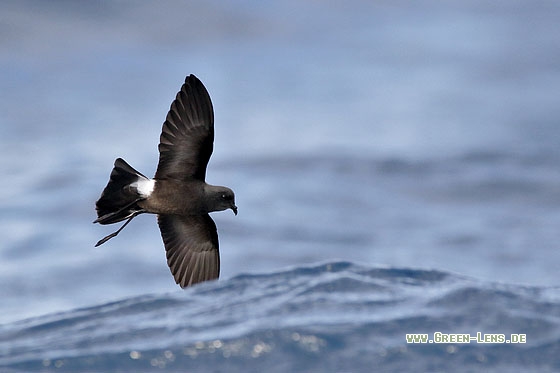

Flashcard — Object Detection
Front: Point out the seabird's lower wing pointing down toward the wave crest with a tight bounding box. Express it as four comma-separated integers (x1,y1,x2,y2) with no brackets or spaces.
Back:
158,214,220,288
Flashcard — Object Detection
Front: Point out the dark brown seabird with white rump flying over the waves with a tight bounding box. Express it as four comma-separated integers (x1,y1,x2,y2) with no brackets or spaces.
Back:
94,75,237,288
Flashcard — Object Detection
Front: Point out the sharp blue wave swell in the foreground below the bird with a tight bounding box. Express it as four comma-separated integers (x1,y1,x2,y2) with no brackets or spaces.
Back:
0,262,560,372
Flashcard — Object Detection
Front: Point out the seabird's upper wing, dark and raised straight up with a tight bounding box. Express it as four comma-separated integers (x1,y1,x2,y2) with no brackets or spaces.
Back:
155,75,214,181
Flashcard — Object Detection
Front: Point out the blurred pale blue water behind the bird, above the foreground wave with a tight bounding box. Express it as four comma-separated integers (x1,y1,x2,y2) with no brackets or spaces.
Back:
0,0,560,323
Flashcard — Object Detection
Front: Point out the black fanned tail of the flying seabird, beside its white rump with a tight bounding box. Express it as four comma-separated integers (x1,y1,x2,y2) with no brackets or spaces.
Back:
94,158,150,224
